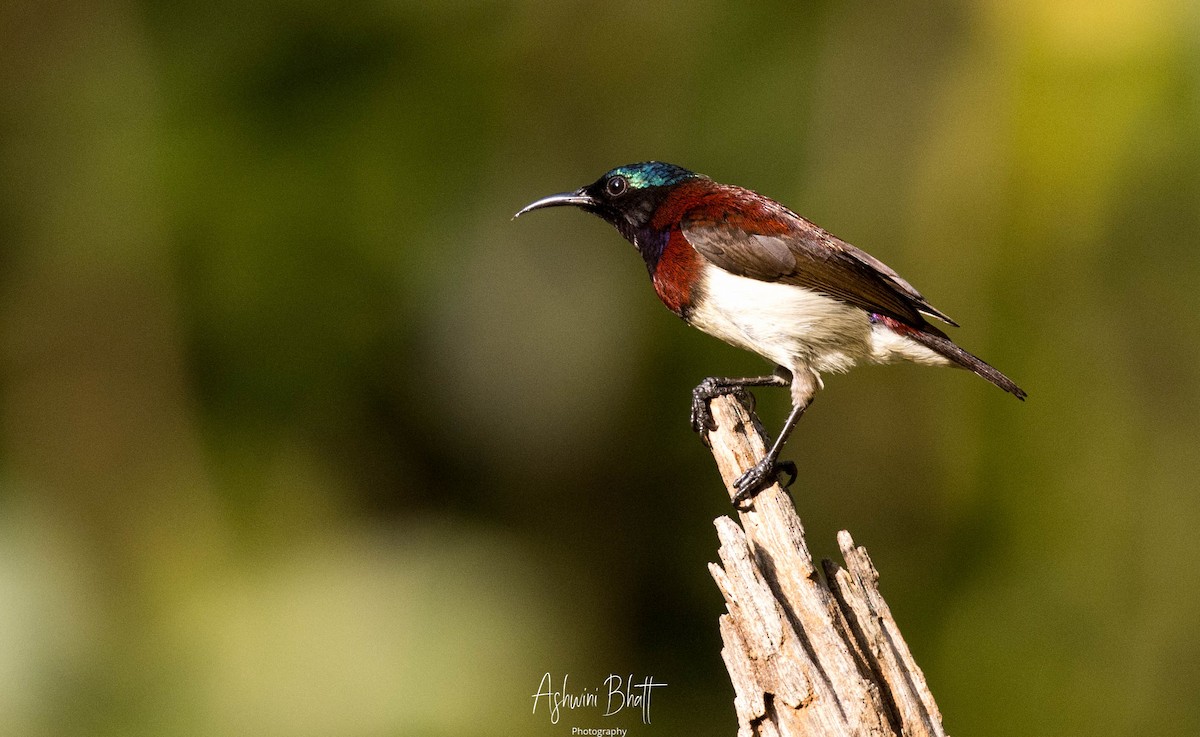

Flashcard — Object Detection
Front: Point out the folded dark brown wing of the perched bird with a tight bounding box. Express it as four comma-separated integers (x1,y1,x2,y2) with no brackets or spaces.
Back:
680,204,958,328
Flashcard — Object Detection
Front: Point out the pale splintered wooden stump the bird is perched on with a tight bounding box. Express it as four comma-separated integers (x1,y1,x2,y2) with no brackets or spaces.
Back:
707,396,946,737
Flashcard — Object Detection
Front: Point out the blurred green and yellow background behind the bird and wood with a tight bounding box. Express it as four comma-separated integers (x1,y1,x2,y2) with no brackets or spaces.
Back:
0,0,1200,736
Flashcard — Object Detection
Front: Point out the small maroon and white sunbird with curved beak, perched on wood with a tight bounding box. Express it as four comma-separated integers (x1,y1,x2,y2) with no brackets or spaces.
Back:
512,161,1027,509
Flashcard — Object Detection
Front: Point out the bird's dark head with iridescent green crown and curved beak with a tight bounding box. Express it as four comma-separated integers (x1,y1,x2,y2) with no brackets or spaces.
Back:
514,161,701,245
